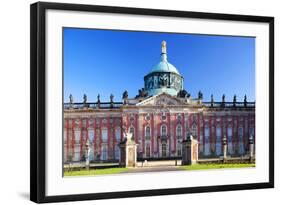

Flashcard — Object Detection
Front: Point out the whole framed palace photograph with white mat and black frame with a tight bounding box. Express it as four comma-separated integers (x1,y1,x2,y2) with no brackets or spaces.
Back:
30,2,274,203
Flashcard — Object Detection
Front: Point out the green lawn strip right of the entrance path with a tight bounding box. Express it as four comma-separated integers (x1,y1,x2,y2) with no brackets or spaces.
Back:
179,163,255,170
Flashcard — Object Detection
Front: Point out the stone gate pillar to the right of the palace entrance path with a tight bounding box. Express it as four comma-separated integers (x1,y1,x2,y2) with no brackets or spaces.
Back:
182,134,198,165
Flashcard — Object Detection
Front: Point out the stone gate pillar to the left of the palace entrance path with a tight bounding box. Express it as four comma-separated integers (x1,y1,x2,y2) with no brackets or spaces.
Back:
119,133,137,167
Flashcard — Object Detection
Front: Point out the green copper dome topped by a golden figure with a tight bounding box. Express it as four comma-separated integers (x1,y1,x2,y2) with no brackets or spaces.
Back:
144,41,183,96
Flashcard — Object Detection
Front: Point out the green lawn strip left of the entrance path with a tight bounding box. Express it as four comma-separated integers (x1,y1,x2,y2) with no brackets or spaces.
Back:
64,168,128,176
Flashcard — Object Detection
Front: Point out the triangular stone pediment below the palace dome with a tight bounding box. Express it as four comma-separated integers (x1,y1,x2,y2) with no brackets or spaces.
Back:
136,93,185,106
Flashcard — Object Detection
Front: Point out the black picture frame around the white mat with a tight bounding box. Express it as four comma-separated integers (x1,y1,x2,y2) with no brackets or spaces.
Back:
30,2,274,203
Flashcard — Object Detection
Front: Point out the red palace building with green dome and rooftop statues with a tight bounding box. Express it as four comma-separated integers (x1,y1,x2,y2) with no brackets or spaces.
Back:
64,41,255,162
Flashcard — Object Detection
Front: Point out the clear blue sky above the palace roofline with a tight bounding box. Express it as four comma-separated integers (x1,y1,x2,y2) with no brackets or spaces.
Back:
63,28,255,102
